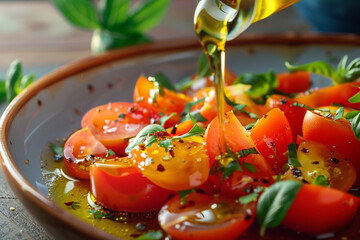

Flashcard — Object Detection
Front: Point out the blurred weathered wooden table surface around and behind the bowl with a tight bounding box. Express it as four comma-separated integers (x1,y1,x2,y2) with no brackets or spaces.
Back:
0,0,309,240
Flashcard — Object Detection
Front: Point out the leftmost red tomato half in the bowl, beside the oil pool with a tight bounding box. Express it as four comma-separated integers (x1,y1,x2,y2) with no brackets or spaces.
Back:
64,128,108,179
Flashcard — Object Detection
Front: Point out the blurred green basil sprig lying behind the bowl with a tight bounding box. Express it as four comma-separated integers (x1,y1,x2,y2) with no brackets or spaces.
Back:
51,0,170,53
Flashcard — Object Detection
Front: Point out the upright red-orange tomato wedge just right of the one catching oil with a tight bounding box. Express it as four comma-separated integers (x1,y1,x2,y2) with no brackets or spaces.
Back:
250,108,293,172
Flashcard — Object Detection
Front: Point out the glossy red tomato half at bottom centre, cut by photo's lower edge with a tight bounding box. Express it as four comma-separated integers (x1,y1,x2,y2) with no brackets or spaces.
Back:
158,193,256,240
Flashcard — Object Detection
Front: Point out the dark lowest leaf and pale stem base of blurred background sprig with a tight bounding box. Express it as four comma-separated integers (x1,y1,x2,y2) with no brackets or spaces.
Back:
91,29,151,53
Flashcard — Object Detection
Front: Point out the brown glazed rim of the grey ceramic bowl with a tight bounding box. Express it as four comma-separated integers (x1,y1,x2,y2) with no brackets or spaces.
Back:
0,33,360,240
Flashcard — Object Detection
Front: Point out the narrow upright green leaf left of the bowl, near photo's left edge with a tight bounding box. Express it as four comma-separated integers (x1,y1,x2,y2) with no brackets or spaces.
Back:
5,60,22,102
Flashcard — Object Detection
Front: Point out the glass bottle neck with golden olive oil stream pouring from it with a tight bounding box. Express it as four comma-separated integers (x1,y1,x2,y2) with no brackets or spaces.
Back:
194,0,299,153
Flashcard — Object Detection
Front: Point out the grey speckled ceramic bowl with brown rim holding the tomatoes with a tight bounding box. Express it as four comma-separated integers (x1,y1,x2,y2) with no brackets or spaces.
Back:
0,35,360,239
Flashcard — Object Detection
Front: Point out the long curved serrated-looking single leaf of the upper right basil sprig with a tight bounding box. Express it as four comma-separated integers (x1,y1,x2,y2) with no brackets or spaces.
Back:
285,61,339,82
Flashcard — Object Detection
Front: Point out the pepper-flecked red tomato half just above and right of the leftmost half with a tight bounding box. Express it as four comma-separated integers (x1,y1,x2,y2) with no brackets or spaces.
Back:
81,102,160,155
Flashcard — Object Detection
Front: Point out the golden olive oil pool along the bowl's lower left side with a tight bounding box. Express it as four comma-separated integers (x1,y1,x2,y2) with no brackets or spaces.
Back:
41,143,160,239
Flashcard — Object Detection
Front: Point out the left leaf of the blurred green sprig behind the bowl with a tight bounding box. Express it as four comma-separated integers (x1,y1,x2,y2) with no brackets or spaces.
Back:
51,0,100,29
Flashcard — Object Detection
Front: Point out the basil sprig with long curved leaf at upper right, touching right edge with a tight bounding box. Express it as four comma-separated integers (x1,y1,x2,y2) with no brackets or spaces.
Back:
285,55,360,84
